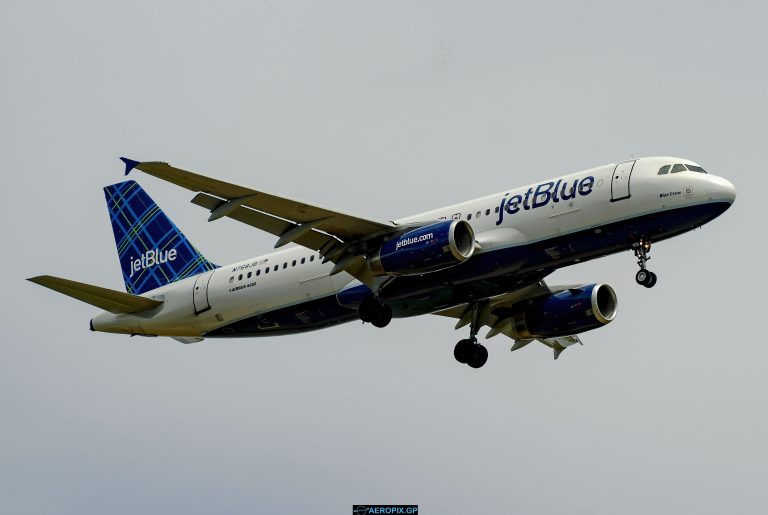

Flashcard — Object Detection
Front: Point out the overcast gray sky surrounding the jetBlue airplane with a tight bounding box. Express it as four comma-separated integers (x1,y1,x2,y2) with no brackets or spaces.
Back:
0,0,768,515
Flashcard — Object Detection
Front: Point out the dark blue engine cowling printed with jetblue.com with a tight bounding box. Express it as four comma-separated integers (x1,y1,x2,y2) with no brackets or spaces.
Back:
368,220,475,275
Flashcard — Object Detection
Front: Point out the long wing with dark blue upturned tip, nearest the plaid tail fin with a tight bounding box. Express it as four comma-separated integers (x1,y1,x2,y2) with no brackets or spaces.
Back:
120,157,397,285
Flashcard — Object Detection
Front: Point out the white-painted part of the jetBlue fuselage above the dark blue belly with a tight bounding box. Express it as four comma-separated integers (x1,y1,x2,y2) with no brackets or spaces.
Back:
92,157,735,337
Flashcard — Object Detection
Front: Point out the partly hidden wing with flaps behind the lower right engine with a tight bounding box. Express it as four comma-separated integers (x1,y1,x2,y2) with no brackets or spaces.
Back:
435,281,581,359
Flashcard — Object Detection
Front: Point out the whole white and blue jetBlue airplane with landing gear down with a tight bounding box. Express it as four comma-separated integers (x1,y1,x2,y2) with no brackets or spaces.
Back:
29,157,736,368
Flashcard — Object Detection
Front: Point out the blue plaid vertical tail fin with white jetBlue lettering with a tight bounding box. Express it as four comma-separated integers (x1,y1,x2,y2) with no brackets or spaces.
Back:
104,181,216,295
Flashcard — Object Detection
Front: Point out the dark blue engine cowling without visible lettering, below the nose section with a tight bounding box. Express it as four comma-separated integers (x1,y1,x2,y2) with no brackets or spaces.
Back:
514,284,618,339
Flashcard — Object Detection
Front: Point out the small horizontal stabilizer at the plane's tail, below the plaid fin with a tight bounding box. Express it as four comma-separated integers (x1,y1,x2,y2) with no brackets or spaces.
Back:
27,275,163,314
